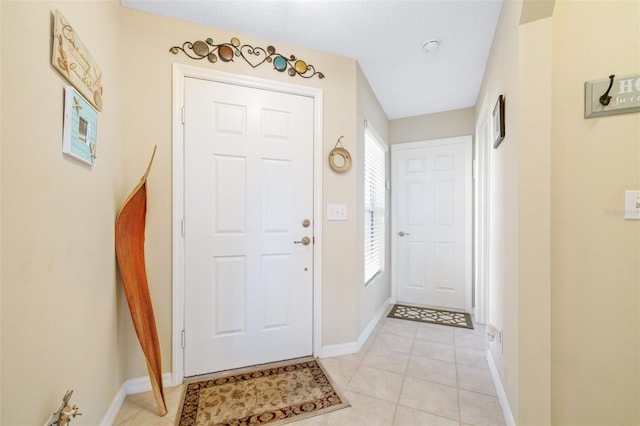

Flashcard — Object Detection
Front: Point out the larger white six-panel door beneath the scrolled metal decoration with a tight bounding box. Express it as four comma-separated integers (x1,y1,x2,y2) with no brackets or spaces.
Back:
184,78,313,376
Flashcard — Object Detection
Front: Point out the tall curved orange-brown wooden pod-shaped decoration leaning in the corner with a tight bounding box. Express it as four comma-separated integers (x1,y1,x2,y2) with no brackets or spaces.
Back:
115,148,167,416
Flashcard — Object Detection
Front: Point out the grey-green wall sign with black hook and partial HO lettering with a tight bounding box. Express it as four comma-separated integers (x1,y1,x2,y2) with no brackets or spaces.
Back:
584,74,640,118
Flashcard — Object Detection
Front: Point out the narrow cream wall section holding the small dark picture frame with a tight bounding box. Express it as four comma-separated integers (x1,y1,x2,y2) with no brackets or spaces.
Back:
476,1,521,421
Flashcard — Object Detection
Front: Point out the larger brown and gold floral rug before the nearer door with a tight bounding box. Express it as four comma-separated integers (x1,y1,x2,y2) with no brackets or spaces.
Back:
176,360,350,426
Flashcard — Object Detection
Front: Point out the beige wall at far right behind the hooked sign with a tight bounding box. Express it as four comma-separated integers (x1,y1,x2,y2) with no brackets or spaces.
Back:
551,0,640,424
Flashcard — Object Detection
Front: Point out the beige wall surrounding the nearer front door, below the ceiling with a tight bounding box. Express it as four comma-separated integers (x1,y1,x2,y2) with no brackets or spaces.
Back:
123,9,376,377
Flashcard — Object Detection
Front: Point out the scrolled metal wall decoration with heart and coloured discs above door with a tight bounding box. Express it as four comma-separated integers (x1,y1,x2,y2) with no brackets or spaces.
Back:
169,37,324,79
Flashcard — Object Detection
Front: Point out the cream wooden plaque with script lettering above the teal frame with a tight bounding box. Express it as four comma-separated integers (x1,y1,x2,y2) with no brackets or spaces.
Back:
51,10,102,111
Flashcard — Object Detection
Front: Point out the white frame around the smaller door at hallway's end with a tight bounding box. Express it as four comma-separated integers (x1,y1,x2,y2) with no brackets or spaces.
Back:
391,135,473,313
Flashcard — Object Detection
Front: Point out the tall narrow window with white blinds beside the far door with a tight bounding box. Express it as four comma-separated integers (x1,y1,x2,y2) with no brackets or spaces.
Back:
364,129,386,285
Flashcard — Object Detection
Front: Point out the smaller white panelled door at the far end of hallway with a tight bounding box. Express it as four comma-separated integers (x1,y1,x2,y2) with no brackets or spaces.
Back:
392,136,471,310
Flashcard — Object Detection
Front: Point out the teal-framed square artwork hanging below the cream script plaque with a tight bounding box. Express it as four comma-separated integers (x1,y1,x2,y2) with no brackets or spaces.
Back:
62,86,98,166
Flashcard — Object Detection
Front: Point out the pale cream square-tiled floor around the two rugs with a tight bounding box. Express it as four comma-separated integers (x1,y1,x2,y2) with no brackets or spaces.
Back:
114,317,505,426
